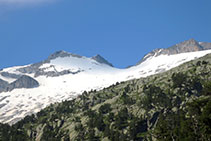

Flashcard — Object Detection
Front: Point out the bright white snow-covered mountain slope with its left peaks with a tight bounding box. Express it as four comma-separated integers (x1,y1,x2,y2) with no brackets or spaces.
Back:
0,40,211,124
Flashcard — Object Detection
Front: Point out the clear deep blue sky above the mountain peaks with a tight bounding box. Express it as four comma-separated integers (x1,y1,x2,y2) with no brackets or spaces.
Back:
0,0,211,68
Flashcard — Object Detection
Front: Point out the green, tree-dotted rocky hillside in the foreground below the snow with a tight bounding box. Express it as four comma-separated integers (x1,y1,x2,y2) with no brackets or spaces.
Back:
0,50,211,141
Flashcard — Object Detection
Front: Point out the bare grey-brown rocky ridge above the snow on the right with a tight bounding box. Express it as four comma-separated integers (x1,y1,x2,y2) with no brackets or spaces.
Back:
137,39,211,65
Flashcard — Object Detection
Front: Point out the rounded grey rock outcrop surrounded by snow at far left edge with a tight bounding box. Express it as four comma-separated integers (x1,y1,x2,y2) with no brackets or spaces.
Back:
0,75,39,92
